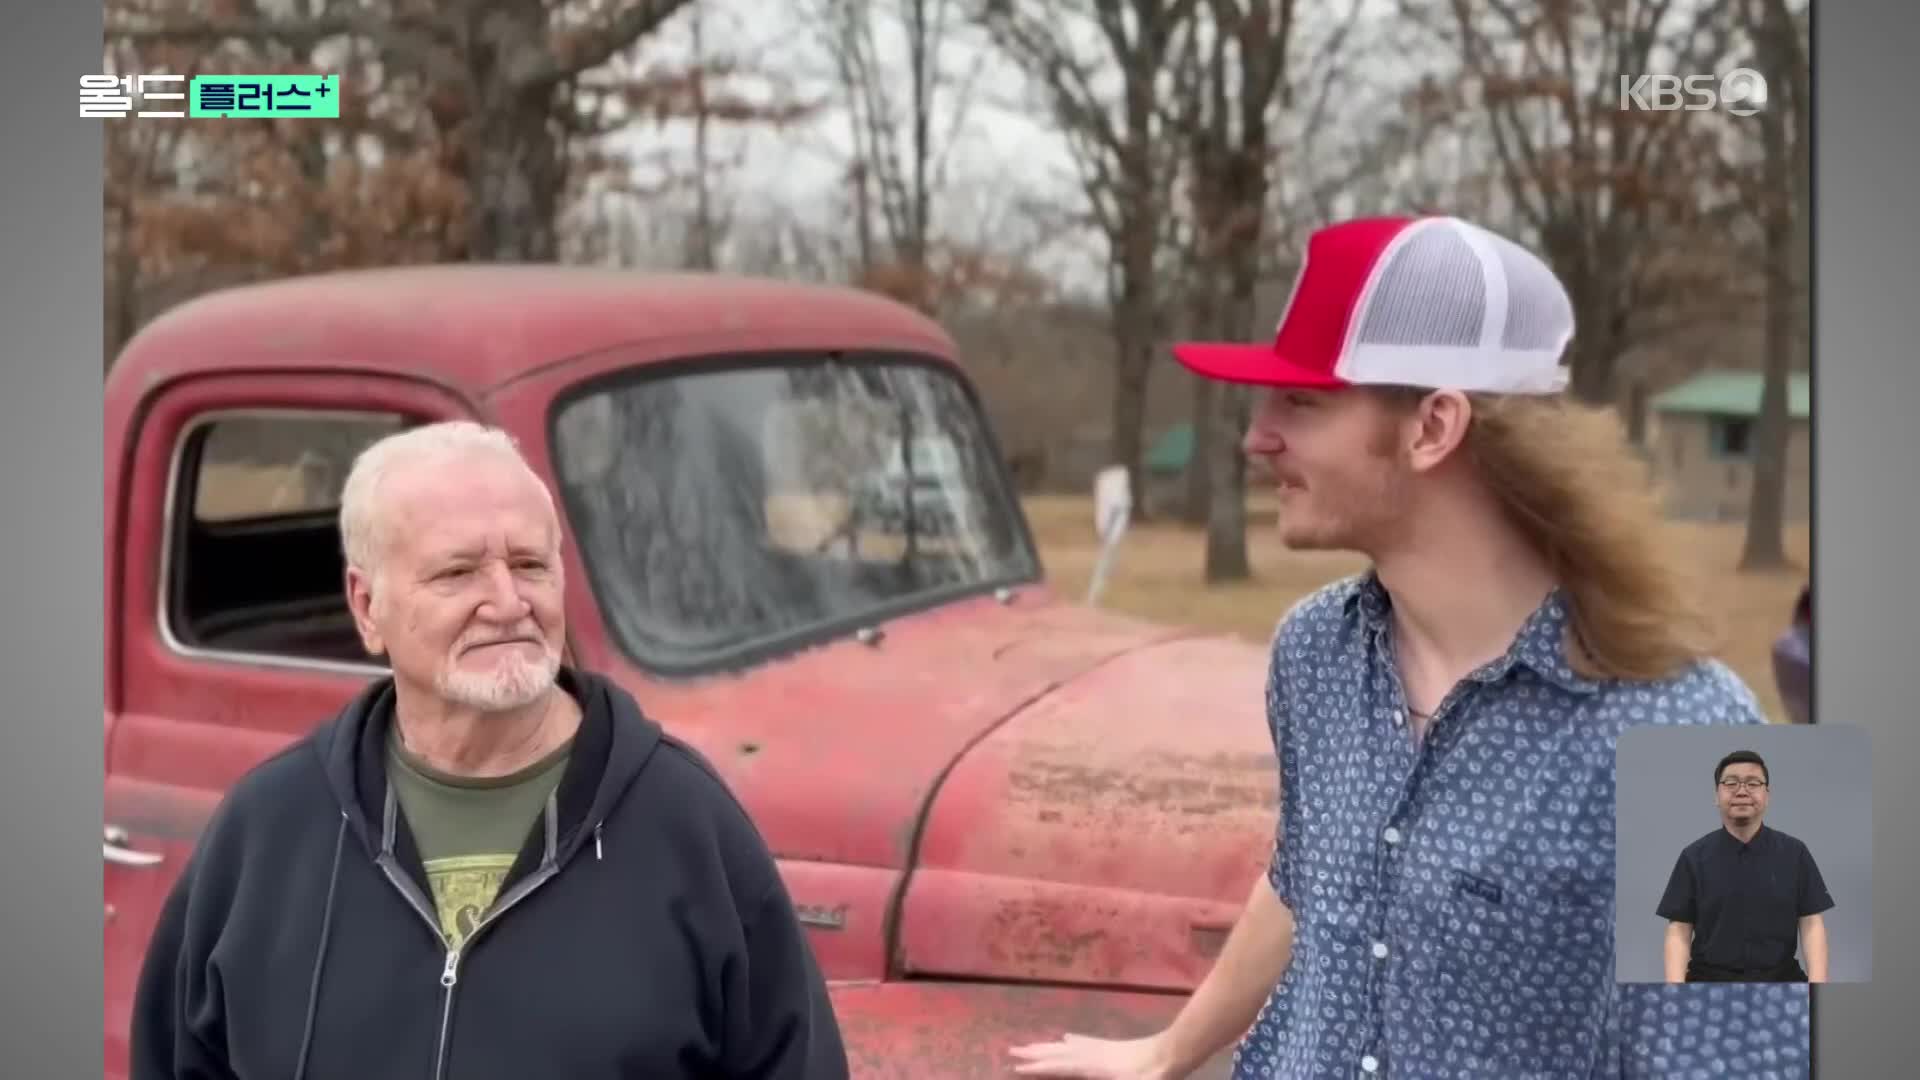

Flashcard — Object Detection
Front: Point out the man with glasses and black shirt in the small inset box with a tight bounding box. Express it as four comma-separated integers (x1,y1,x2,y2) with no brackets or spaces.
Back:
1659,749,1834,982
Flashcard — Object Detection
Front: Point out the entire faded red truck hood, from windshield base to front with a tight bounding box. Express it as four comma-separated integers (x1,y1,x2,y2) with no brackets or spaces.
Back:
636,590,1277,988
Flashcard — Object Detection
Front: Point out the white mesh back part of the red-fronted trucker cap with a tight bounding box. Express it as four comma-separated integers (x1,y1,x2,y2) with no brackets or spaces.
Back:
1338,217,1572,394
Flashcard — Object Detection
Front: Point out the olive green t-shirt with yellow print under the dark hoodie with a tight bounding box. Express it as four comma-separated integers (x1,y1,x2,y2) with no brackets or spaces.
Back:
386,726,572,947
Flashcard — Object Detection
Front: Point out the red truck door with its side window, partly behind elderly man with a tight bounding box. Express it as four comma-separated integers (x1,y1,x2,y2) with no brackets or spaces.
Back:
102,373,472,1078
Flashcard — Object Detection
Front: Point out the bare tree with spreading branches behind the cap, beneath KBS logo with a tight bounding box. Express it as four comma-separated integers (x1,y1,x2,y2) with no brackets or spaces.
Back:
1404,0,1740,420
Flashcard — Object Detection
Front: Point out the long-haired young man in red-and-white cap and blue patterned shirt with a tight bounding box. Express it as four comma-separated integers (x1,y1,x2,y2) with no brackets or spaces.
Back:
1014,217,1807,1080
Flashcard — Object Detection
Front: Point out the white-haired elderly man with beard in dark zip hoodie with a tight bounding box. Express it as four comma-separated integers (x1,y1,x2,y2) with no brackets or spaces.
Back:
131,423,847,1080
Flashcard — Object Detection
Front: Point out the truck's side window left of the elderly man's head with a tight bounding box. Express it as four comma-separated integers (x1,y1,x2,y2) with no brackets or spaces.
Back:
163,409,411,665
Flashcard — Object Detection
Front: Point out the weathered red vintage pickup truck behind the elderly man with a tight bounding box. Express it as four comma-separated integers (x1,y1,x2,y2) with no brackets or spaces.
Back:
104,267,1279,1078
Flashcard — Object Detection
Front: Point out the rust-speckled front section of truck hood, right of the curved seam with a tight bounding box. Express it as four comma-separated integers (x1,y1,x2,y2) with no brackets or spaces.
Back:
899,638,1279,990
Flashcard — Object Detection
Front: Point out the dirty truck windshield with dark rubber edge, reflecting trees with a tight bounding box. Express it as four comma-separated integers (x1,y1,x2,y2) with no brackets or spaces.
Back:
553,356,1039,675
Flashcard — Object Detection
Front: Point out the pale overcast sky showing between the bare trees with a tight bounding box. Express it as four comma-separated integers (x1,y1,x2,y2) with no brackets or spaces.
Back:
576,0,1751,292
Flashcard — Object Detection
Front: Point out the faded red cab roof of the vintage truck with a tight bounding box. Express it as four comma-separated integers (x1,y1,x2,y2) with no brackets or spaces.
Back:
109,263,954,398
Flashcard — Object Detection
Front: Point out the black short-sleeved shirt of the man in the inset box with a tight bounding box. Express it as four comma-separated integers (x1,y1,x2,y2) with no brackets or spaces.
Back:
1659,824,1834,972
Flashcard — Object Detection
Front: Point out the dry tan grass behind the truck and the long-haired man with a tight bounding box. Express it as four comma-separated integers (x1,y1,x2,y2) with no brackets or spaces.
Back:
1025,496,1809,723
